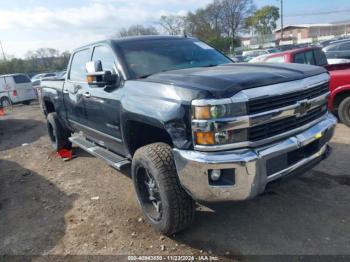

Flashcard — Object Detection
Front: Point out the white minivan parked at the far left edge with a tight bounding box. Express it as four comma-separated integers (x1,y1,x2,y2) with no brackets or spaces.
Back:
0,74,37,106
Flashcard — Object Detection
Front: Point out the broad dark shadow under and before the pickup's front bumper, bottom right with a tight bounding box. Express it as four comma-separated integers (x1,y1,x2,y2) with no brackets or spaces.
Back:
175,143,350,255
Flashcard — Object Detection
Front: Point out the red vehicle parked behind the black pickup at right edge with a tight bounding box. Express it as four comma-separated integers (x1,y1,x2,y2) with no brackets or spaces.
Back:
260,47,350,127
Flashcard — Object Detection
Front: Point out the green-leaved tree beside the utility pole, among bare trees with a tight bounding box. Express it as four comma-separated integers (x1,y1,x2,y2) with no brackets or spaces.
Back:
246,5,280,35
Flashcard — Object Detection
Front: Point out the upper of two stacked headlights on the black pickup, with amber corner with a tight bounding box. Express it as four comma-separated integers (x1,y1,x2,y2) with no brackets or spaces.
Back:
193,102,247,120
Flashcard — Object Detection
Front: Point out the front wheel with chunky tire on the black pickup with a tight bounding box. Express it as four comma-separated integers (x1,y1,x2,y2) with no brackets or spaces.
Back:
132,143,195,235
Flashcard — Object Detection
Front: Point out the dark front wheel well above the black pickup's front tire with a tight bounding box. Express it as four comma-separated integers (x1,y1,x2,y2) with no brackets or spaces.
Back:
126,121,173,156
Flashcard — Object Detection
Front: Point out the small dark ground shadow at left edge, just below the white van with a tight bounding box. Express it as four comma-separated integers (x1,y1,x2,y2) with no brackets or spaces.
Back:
0,119,47,151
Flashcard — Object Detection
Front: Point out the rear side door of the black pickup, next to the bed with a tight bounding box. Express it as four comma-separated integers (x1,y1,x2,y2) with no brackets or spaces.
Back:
63,48,91,130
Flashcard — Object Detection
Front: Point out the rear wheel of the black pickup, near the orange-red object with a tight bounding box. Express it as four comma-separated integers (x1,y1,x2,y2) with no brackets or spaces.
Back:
47,113,72,151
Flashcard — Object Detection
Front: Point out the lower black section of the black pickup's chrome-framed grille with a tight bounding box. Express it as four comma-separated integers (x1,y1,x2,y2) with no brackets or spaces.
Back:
249,106,327,142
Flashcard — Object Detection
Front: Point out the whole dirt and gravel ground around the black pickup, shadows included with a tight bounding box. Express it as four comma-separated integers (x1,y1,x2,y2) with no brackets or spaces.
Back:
0,105,350,256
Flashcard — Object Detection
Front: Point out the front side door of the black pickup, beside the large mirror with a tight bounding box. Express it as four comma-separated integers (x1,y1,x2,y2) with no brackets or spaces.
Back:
84,44,124,154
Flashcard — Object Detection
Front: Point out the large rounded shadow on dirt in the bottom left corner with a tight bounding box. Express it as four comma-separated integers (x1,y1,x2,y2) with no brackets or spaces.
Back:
0,160,76,255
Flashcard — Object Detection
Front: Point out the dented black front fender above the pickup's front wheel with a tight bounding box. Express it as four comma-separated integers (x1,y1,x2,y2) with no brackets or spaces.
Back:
120,81,205,154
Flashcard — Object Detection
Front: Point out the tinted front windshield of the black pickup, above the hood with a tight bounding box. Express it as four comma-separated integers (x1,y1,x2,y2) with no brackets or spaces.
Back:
119,38,232,79
